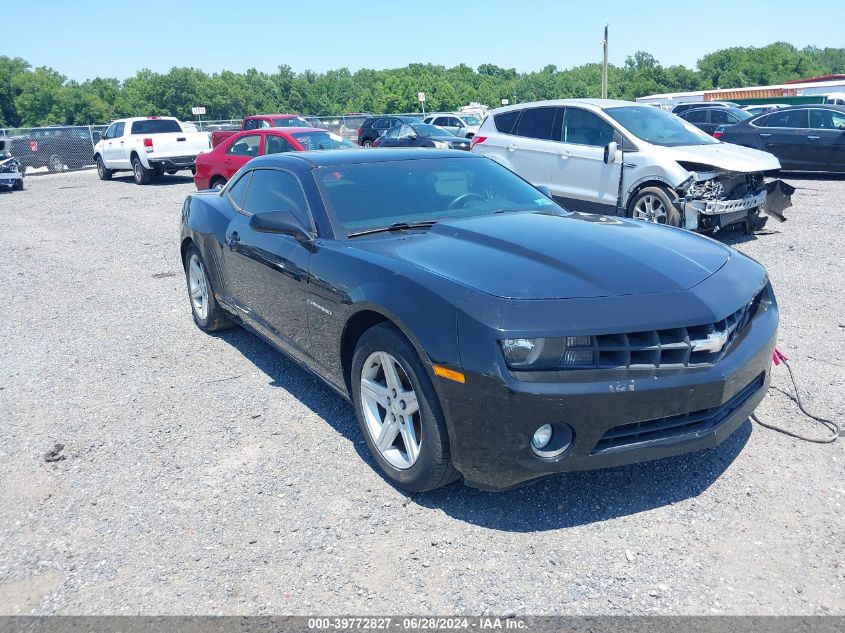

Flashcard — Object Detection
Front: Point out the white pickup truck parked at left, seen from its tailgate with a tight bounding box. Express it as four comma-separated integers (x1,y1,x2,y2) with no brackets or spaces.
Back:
94,116,211,185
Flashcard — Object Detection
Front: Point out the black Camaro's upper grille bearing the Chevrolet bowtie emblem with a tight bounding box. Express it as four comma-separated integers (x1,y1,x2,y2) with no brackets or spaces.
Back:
560,290,765,369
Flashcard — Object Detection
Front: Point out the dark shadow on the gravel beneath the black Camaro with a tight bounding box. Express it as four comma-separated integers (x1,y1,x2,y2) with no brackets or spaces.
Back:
217,328,751,532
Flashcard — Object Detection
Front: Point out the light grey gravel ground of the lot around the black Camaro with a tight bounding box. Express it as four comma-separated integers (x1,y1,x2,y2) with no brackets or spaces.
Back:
0,167,845,615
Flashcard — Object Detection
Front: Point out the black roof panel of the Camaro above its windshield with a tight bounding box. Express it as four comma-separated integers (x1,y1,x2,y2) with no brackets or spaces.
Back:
249,147,478,167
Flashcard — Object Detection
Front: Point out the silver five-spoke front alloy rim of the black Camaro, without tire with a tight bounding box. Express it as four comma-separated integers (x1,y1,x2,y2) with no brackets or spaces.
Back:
360,351,422,470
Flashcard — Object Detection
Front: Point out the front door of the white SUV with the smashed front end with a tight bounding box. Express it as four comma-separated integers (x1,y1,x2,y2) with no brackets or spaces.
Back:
551,106,622,215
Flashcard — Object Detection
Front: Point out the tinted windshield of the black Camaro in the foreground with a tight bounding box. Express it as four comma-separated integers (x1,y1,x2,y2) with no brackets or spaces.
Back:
313,158,564,234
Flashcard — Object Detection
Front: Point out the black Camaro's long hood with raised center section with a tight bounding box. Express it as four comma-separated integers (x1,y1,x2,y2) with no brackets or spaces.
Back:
352,212,732,299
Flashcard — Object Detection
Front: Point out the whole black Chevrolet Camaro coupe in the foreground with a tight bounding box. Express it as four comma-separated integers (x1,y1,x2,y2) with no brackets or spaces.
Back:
181,150,778,491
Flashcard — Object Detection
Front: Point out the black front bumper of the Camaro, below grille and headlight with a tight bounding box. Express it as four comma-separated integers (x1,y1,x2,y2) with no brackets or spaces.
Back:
439,292,778,490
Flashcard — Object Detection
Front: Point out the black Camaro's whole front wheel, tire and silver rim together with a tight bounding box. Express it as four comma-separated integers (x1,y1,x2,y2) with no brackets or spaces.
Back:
350,323,459,492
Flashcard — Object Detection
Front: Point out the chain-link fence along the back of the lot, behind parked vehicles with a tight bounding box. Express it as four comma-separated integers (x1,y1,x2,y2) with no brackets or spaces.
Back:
0,112,422,175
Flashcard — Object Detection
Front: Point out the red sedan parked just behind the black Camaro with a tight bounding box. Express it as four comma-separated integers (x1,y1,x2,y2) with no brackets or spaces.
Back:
194,127,357,191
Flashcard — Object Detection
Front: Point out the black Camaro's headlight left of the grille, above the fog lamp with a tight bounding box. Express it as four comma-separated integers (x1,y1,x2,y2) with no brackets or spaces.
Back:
499,336,595,371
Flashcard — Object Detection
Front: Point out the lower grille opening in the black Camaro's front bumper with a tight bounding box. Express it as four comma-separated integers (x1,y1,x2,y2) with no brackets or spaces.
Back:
593,374,765,455
